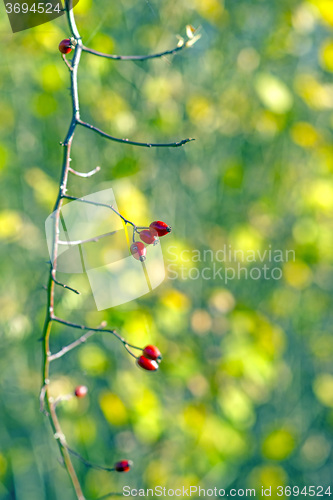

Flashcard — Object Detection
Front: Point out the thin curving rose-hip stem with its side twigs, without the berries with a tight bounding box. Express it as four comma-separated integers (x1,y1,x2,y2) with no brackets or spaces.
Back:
40,0,194,500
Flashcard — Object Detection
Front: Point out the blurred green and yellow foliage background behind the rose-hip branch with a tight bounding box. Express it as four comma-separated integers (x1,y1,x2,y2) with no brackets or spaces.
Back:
0,0,333,500
